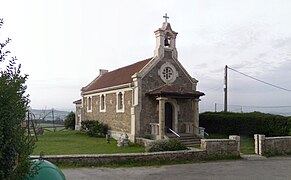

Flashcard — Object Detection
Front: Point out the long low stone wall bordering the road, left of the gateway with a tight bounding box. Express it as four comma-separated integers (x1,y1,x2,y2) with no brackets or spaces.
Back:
31,136,240,166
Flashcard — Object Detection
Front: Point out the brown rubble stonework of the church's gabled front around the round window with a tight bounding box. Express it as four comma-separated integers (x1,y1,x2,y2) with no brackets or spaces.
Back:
140,52,194,134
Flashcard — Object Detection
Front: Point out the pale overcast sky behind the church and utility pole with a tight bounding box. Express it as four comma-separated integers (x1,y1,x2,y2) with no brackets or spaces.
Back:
0,0,291,114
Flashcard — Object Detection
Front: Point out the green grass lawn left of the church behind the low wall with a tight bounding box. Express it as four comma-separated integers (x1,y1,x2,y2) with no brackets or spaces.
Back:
33,130,145,155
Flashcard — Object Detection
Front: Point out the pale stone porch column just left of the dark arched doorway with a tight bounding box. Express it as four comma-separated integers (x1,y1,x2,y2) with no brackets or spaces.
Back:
157,97,167,139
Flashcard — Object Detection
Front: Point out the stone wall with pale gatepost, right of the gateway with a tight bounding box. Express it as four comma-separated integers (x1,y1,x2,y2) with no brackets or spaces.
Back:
254,134,291,155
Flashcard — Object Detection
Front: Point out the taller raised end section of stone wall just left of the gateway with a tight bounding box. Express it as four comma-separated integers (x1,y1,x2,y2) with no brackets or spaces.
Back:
201,135,240,157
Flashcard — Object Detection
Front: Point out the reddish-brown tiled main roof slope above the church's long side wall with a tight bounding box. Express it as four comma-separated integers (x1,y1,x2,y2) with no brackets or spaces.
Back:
82,58,152,92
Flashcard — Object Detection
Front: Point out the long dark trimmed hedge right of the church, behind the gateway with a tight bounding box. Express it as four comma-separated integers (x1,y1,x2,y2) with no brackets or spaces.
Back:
199,112,291,136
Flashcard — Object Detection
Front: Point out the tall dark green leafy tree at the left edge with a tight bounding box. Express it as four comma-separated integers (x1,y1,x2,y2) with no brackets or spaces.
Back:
0,19,34,179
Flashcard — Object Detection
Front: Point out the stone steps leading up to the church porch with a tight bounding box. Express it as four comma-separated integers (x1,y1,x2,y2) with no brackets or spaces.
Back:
166,134,201,147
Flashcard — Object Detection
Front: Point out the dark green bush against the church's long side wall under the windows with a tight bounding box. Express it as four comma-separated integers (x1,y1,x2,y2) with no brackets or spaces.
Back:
81,120,108,136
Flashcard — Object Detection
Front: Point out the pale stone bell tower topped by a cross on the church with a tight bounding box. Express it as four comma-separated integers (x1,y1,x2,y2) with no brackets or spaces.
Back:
154,13,178,59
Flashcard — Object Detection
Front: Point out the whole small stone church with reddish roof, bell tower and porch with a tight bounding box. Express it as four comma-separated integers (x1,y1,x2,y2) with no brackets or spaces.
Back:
74,19,204,141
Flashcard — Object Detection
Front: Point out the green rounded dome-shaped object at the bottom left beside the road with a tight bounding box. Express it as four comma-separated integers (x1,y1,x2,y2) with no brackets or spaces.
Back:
28,159,66,180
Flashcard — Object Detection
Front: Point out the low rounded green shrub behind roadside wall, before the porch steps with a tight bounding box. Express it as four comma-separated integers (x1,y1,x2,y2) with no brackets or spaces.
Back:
146,139,188,152
